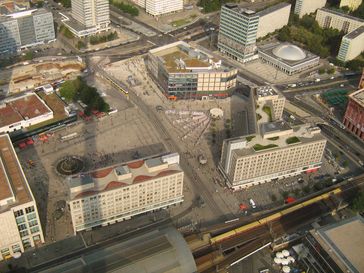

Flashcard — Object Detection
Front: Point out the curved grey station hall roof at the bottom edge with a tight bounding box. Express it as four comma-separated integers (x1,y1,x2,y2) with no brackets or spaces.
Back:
37,227,197,273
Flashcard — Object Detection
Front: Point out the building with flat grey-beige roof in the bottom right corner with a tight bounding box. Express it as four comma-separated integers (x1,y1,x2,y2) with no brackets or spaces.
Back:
293,216,364,273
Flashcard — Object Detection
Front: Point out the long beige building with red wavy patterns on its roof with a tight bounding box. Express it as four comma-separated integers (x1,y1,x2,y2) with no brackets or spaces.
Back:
69,154,183,233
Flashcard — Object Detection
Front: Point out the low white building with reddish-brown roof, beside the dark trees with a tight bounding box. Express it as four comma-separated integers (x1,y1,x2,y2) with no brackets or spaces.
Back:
0,92,53,133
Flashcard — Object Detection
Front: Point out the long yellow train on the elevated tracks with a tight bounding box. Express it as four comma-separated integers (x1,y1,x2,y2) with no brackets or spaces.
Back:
210,188,342,245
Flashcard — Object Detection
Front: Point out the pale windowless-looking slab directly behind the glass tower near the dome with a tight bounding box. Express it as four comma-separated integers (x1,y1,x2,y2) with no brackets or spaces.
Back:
257,2,291,38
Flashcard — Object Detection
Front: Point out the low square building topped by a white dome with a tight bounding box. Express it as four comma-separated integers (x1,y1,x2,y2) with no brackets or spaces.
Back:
258,43,320,75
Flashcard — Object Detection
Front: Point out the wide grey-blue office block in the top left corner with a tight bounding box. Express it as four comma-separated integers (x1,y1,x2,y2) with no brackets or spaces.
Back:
0,9,55,53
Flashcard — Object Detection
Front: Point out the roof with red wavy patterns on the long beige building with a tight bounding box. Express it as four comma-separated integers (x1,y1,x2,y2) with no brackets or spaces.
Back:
67,154,182,200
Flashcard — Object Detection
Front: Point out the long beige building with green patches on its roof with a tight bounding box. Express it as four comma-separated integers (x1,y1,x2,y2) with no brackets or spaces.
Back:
220,121,326,190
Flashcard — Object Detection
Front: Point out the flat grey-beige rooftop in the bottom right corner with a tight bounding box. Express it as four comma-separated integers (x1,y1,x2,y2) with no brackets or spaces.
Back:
311,216,364,273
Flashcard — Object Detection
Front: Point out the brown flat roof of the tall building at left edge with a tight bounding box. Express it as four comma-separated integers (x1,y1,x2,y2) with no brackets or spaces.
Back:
0,134,33,212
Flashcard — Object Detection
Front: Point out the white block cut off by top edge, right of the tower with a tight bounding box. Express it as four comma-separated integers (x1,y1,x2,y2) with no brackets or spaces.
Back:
132,0,183,16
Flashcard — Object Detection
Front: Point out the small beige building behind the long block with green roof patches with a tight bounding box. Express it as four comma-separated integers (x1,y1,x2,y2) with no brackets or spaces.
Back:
255,86,286,121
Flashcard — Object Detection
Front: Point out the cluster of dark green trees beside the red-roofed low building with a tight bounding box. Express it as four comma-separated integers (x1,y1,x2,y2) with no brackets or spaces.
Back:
60,77,110,115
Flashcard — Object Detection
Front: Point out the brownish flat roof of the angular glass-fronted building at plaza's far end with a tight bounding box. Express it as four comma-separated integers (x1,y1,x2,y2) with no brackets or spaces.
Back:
150,41,232,73
